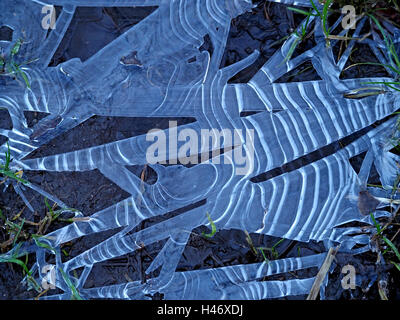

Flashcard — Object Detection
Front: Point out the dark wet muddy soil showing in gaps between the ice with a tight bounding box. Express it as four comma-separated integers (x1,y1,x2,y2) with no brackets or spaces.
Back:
0,1,400,300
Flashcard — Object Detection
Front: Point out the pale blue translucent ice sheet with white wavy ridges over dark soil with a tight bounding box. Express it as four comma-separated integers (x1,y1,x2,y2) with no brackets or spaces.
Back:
0,0,400,299
